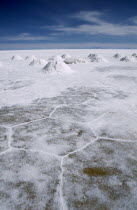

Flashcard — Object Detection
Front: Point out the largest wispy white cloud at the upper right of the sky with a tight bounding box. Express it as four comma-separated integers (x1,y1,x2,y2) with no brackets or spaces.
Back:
41,11,137,36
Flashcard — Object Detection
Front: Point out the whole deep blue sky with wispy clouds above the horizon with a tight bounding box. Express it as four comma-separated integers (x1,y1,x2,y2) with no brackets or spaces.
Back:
0,0,137,50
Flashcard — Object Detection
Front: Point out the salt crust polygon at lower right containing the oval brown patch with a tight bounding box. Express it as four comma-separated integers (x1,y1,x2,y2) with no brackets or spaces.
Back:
63,139,137,210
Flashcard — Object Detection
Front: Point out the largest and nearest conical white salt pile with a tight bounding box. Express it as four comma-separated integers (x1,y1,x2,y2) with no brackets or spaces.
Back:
42,56,73,74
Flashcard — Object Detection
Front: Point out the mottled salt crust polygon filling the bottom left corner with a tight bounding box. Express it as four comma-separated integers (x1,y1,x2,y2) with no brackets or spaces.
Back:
0,150,60,210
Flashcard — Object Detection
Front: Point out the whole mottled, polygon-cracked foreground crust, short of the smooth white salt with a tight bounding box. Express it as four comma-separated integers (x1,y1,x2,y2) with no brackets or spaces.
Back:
0,87,137,210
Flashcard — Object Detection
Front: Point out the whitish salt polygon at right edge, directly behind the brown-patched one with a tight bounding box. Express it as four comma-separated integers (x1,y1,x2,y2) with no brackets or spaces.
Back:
91,110,137,141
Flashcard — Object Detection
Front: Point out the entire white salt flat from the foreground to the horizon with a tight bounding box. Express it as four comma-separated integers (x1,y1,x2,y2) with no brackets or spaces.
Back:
0,49,137,210
